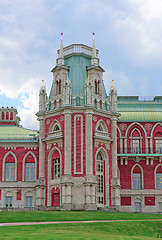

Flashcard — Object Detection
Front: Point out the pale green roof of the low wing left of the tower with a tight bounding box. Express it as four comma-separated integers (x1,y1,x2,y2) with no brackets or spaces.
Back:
0,125,39,142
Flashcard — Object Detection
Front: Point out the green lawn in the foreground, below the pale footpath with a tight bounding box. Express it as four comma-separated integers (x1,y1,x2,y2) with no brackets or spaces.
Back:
0,220,162,240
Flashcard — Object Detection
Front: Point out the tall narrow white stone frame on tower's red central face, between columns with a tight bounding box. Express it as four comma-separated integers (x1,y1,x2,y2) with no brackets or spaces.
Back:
74,114,83,174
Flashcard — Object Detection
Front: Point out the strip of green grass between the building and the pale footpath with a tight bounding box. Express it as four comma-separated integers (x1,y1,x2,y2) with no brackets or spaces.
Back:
0,211,162,223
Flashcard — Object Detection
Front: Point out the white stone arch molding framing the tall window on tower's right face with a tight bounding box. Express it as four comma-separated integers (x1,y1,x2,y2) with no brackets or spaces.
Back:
95,147,110,206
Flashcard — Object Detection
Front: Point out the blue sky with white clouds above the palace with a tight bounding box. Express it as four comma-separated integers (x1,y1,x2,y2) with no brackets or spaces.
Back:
0,0,162,129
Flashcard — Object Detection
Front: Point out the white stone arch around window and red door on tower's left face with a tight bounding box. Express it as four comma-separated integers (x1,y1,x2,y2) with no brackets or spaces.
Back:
47,147,62,206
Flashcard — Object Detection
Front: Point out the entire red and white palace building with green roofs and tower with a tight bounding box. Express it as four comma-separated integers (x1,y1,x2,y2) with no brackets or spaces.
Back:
0,35,162,212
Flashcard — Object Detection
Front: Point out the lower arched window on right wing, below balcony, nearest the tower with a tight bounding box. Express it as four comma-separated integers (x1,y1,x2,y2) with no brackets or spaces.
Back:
132,166,142,189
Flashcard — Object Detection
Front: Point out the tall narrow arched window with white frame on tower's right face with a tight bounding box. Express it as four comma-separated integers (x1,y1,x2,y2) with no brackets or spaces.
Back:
96,152,104,207
